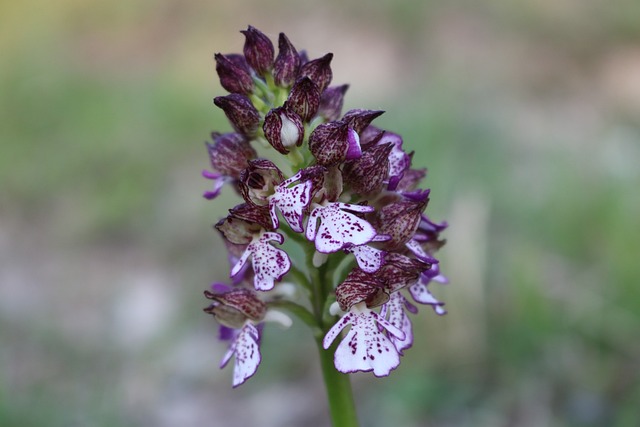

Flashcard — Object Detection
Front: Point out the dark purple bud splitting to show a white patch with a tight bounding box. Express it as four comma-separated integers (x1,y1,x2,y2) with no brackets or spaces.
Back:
262,103,304,154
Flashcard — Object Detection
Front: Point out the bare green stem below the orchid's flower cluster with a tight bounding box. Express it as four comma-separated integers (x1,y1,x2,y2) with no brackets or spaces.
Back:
316,337,359,427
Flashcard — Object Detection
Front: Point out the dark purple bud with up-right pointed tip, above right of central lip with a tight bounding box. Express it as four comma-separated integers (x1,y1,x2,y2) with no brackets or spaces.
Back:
342,144,393,194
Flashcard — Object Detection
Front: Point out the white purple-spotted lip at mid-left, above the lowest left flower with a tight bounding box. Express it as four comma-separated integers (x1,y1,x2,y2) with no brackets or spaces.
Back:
231,232,291,291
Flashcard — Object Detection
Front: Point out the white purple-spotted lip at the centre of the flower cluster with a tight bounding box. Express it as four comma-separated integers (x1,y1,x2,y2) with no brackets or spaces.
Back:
306,203,376,254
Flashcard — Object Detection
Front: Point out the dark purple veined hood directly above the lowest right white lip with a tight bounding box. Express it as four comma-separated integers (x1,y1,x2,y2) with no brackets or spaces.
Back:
336,267,389,311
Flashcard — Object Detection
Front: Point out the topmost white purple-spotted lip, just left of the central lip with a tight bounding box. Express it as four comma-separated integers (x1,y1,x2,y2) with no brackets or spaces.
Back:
269,172,313,233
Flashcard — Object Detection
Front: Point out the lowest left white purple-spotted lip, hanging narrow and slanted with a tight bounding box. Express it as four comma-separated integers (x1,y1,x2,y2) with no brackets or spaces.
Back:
220,323,262,388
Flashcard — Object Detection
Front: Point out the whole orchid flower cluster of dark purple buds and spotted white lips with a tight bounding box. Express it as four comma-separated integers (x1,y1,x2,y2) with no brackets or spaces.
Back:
203,26,446,386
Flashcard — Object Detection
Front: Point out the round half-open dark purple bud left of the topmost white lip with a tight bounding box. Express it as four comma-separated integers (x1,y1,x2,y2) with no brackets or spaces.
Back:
239,159,284,206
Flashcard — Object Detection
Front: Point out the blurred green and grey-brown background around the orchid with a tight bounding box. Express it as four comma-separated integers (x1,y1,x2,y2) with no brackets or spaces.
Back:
0,0,640,427
